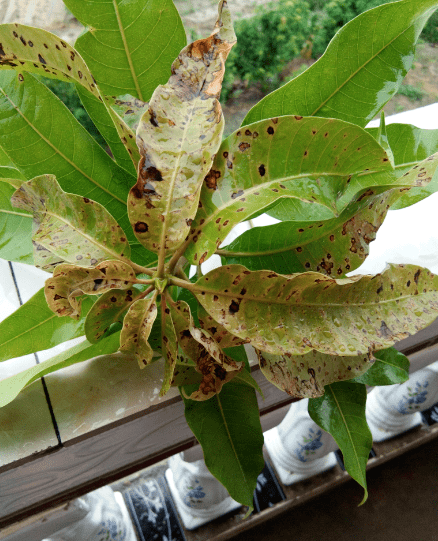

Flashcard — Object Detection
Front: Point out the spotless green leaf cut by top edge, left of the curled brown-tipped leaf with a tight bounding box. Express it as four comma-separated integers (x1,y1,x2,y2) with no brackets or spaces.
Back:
64,0,187,101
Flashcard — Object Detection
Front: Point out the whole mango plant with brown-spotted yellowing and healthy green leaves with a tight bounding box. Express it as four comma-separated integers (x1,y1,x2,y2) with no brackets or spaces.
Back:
0,0,438,507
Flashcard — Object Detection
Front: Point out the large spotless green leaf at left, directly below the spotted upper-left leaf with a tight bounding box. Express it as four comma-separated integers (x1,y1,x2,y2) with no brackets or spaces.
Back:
0,71,136,249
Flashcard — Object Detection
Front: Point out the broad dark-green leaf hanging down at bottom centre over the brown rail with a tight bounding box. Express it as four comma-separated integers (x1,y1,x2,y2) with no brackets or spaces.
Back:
182,380,264,508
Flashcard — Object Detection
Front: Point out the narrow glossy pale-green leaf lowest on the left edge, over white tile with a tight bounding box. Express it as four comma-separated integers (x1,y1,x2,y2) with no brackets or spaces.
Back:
0,333,119,408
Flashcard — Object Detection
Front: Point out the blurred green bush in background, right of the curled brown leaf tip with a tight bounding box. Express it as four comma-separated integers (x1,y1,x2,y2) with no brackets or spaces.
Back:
222,0,313,101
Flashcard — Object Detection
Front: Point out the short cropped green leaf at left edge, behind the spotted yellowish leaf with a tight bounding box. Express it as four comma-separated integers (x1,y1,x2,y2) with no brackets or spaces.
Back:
0,179,33,265
